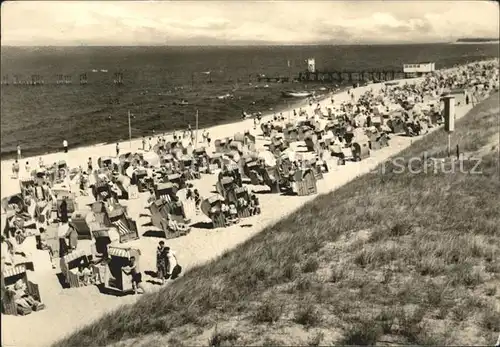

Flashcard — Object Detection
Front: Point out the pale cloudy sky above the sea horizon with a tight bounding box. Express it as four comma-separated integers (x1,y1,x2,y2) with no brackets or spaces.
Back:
1,0,499,46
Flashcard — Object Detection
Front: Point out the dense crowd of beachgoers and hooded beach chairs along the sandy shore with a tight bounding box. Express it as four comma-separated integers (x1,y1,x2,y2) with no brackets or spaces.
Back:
1,60,499,346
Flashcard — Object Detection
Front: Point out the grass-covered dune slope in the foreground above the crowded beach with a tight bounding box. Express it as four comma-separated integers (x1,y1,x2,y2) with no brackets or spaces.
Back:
55,94,500,346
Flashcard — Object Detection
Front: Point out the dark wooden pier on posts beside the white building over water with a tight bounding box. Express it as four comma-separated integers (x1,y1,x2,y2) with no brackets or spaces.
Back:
298,70,407,83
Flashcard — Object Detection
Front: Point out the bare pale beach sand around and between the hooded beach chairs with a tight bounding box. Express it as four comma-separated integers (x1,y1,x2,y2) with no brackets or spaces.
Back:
1,71,471,347
